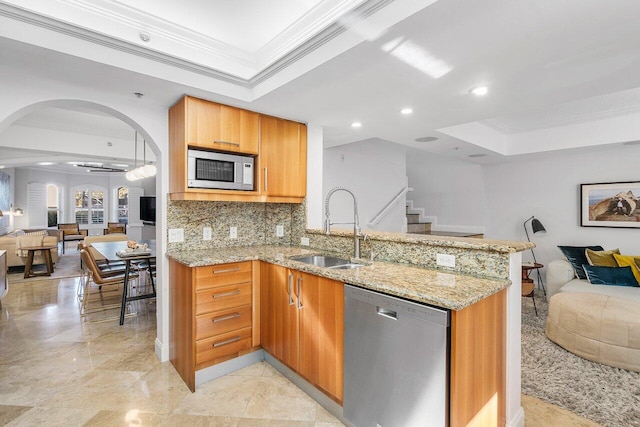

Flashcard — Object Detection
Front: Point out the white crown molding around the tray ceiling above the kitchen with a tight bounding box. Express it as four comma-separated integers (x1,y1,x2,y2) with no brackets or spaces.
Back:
0,0,395,89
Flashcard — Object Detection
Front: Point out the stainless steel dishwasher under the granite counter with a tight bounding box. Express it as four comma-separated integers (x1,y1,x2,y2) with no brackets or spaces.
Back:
343,285,450,427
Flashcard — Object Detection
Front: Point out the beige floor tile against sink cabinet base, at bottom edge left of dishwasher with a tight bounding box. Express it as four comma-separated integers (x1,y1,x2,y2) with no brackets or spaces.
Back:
244,376,317,421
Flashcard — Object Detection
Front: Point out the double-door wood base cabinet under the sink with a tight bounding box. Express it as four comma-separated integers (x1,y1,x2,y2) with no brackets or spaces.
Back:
260,263,344,404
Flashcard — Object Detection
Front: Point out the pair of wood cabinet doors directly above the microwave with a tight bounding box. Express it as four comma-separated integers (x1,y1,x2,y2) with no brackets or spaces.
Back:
181,96,260,154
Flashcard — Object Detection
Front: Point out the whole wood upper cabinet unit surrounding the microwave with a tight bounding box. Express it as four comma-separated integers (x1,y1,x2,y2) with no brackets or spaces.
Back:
169,96,307,203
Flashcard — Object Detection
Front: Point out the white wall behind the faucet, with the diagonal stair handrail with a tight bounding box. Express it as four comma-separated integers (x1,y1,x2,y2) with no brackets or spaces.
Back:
323,140,407,232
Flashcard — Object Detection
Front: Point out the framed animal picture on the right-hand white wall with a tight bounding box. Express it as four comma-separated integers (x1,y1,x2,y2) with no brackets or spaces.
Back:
580,181,640,228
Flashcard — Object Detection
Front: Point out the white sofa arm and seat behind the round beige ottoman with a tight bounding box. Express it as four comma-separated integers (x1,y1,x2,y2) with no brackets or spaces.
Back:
545,259,640,302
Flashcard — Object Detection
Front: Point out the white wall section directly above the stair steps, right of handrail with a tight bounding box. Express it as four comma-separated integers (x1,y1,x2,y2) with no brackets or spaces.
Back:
407,150,486,232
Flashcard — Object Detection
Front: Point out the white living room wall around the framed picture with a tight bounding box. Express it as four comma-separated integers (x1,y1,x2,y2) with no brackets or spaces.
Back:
482,146,640,265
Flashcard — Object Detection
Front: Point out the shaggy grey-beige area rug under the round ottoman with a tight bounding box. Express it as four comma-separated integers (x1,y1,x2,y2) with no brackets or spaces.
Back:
522,291,640,427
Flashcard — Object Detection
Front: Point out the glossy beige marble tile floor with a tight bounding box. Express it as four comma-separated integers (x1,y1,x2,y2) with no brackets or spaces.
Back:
0,279,595,427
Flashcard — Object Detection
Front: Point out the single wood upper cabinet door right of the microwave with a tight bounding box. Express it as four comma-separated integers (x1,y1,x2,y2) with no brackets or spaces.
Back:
259,116,307,197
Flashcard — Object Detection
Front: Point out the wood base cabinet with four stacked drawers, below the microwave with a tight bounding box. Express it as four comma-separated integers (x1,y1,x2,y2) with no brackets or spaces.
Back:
169,260,260,391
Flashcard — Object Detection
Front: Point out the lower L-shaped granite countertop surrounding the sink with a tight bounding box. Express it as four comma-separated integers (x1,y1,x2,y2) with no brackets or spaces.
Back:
167,245,511,310
